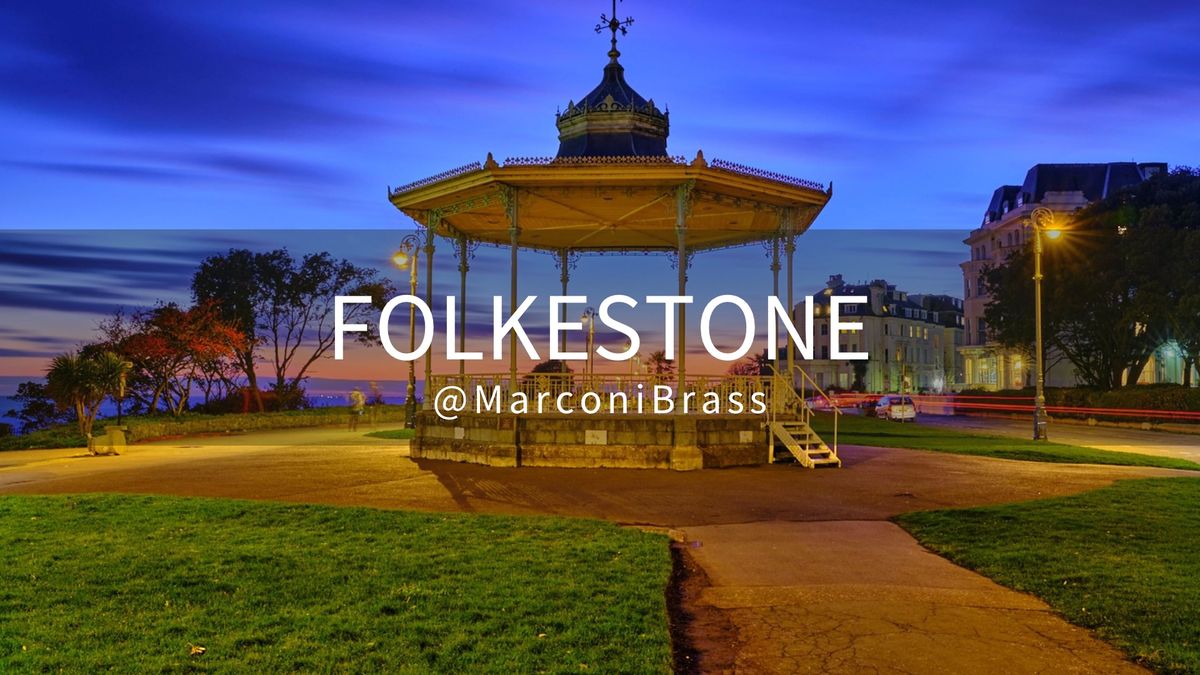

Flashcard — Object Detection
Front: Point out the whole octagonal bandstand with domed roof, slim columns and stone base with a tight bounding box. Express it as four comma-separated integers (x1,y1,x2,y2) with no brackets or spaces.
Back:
389,6,840,470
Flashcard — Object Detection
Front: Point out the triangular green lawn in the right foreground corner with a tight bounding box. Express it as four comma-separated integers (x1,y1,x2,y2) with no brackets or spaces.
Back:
896,478,1200,673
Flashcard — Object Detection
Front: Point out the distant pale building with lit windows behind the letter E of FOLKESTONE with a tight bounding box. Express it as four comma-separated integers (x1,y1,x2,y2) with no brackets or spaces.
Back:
796,274,962,393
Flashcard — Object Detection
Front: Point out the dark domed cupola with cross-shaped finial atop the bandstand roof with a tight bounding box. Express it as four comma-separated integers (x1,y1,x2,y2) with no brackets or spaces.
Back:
557,4,670,157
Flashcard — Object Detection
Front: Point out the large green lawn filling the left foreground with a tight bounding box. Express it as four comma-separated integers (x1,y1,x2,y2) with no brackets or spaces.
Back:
0,495,671,673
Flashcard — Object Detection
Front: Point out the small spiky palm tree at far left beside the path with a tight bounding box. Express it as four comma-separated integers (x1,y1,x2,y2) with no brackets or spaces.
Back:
46,352,131,446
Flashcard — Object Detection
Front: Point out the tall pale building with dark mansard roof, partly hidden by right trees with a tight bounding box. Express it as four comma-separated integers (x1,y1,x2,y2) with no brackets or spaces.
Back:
959,162,1166,390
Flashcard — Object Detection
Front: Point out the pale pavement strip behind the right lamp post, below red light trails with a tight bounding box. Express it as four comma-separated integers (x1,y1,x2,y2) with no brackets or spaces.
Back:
920,414,1200,461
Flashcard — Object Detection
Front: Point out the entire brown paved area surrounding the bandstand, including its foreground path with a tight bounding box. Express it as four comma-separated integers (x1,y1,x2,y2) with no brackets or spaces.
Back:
0,429,1183,673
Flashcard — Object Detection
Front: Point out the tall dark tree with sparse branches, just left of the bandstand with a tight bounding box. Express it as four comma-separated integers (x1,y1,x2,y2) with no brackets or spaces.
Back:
192,249,394,410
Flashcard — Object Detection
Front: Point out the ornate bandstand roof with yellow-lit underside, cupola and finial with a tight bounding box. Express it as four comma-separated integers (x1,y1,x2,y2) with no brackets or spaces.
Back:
388,4,832,251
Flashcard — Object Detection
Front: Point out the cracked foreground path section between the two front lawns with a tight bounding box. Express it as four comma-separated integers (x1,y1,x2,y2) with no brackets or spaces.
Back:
688,520,1142,674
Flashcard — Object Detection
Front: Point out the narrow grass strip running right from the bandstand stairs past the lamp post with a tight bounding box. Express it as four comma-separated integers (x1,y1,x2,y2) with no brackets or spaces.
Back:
812,413,1200,470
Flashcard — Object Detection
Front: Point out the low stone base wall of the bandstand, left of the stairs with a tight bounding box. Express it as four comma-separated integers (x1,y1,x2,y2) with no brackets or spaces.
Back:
409,411,769,471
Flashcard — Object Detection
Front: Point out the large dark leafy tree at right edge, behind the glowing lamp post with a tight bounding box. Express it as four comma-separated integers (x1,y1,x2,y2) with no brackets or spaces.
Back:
985,168,1200,389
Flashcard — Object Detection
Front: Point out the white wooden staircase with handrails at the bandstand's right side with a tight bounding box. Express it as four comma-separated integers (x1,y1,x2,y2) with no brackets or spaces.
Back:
767,369,841,468
